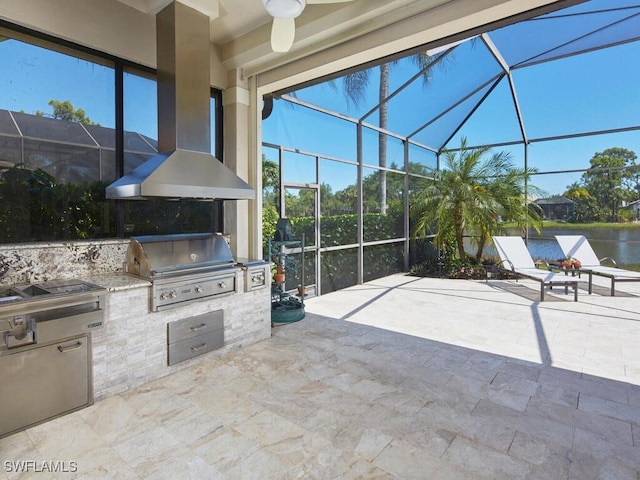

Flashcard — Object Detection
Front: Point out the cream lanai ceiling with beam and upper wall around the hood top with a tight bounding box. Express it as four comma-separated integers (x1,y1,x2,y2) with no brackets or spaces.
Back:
0,0,584,95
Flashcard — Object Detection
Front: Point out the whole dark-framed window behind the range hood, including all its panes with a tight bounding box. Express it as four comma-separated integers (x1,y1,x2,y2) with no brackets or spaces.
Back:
0,23,223,243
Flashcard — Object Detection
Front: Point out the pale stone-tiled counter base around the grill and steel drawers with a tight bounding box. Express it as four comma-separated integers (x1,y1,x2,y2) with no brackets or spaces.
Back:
82,270,271,401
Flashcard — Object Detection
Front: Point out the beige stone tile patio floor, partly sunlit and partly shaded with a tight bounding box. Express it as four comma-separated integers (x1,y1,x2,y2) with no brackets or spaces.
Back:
0,275,640,480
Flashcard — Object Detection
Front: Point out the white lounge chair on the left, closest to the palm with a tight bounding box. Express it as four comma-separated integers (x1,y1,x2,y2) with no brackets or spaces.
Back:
493,237,580,302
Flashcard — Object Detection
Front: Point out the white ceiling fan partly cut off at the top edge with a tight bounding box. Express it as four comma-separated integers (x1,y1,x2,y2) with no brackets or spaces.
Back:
262,0,353,52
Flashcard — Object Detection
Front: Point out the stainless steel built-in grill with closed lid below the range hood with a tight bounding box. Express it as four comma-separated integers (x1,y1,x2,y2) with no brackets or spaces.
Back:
126,233,266,311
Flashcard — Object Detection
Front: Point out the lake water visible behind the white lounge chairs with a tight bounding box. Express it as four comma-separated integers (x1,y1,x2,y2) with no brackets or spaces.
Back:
487,228,640,270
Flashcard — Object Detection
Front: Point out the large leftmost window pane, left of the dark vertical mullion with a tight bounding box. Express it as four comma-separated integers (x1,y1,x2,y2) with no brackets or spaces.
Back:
0,31,115,243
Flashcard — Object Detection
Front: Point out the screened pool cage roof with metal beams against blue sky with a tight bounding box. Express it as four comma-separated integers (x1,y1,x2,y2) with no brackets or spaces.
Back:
281,0,640,156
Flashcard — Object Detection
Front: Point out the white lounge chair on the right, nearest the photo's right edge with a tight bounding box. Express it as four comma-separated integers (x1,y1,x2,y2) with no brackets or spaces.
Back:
555,235,640,297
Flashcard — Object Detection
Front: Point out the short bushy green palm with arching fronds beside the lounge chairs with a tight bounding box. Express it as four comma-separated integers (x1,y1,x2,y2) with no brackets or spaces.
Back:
411,138,541,260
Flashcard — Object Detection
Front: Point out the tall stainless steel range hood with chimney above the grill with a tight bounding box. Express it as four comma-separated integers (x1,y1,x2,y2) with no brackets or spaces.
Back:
106,1,255,200
